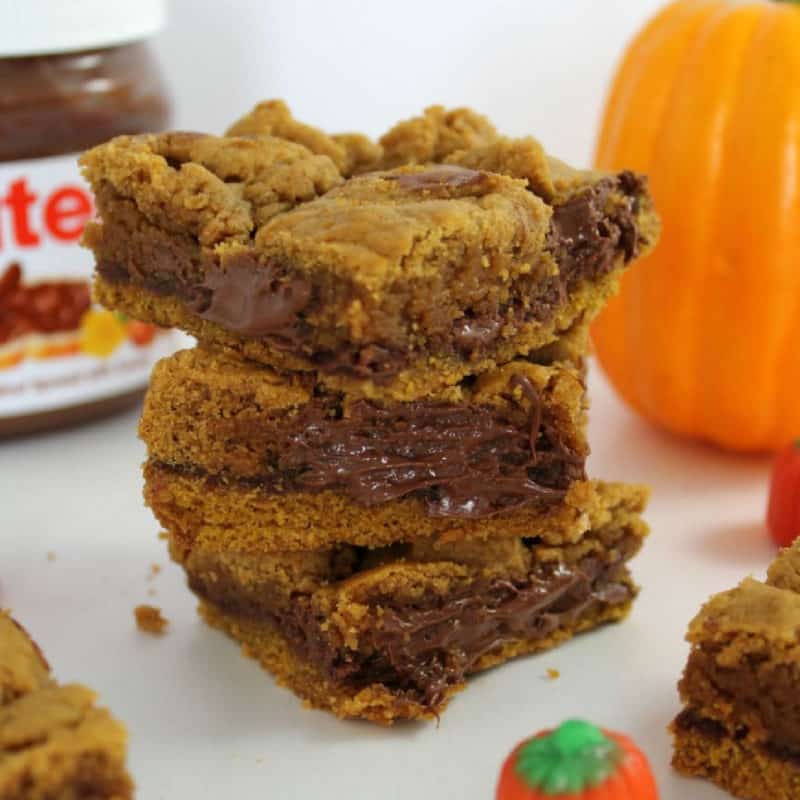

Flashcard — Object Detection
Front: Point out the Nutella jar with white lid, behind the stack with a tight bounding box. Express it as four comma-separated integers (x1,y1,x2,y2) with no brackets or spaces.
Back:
0,0,174,436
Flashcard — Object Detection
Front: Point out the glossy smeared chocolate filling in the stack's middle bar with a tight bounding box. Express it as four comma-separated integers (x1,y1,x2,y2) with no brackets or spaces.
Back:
155,375,586,519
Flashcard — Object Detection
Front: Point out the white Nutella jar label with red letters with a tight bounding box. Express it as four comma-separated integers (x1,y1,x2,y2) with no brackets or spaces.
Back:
0,155,175,419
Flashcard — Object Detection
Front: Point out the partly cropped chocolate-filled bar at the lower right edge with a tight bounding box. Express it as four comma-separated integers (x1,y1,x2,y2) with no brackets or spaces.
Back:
672,544,800,800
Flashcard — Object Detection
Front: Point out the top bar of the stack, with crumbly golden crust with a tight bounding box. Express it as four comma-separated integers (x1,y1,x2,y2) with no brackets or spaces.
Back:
83,101,658,400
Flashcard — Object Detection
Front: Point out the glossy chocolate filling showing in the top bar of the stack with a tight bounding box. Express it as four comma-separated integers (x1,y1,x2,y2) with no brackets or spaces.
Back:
97,167,644,382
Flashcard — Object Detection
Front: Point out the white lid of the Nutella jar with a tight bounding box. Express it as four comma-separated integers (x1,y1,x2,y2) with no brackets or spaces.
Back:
0,0,167,58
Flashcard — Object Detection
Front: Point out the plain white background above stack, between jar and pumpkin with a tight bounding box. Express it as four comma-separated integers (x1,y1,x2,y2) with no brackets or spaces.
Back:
157,0,662,166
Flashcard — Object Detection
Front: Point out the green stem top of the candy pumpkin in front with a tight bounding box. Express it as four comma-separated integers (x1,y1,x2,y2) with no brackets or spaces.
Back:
515,719,622,797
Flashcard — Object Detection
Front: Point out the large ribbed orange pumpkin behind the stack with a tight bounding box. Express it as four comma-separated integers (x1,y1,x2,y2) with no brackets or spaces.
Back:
593,0,800,451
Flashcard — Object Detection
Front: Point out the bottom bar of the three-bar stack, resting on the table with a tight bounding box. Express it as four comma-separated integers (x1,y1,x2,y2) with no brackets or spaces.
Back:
170,482,647,724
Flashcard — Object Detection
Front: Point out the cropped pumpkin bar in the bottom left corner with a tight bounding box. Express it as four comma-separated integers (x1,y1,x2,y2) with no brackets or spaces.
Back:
0,611,133,800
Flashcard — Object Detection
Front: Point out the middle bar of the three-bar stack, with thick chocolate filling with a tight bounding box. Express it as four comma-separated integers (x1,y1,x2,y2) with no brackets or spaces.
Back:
140,347,588,550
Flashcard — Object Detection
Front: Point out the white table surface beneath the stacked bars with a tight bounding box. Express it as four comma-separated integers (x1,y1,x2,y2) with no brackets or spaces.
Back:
0,368,774,800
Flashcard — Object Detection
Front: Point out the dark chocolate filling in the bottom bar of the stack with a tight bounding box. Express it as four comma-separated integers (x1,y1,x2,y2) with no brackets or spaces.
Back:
189,558,634,709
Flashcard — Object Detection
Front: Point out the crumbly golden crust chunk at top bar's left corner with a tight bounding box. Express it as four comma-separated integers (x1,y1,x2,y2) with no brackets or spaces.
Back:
81,131,342,241
